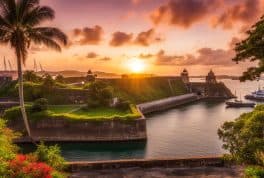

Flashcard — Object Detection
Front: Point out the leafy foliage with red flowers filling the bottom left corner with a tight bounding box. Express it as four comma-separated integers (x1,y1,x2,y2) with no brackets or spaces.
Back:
0,119,66,178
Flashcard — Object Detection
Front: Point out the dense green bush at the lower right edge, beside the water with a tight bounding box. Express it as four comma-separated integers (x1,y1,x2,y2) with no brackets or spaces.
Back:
218,105,264,178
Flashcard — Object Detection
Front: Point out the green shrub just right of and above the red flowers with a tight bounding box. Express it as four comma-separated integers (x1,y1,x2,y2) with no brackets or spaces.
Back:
34,142,65,171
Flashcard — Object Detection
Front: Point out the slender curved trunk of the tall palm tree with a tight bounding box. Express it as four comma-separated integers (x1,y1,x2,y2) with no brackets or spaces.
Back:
17,52,31,138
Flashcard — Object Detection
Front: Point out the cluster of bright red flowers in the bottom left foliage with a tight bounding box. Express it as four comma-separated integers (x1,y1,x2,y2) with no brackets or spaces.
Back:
9,155,53,178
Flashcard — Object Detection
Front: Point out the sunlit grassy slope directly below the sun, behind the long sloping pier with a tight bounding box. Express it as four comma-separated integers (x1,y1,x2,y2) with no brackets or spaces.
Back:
107,77,187,104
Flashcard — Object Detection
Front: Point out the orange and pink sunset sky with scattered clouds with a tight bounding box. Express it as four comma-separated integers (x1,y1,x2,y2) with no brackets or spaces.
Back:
0,0,264,75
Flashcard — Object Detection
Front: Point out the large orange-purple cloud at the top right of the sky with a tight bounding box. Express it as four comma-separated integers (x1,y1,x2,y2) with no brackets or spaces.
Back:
150,0,261,29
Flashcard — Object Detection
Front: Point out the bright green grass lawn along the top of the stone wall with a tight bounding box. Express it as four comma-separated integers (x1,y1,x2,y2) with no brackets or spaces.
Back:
5,105,141,121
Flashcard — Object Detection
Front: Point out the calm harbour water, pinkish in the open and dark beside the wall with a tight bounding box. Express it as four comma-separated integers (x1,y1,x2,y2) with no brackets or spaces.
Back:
19,79,264,161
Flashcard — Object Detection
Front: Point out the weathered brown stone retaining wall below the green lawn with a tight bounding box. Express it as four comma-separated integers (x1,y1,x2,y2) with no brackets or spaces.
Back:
8,118,147,143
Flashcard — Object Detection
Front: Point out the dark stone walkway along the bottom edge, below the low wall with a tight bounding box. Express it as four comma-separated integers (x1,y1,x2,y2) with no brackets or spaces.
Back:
70,167,243,178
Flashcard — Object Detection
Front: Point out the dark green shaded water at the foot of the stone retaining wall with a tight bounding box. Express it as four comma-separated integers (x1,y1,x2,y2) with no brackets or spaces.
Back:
20,141,146,161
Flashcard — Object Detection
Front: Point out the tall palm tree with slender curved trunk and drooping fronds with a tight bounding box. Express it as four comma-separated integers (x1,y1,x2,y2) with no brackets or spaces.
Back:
0,0,67,138
